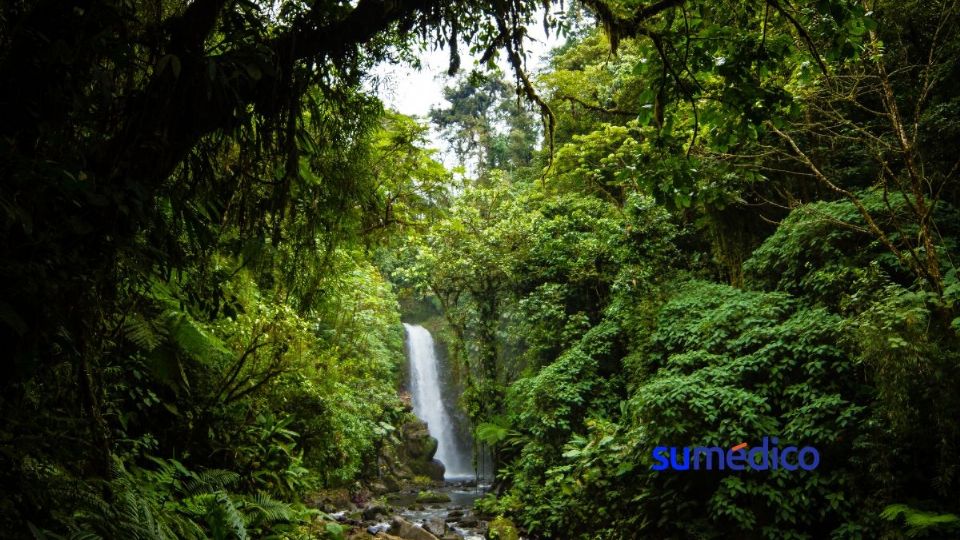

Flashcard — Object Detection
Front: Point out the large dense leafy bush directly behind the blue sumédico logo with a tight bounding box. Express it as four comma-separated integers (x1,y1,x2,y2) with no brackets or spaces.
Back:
631,282,863,538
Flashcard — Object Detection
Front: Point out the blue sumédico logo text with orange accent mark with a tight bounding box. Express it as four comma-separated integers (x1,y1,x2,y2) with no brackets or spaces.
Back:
650,437,820,471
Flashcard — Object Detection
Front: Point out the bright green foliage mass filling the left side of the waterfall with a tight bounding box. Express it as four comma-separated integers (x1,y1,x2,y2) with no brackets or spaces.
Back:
0,37,432,538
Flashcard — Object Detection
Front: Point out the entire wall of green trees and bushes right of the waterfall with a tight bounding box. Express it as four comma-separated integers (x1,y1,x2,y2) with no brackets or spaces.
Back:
426,1,960,539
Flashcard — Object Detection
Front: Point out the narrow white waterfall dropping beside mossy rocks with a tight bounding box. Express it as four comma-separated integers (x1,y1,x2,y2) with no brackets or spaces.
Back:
403,323,474,479
